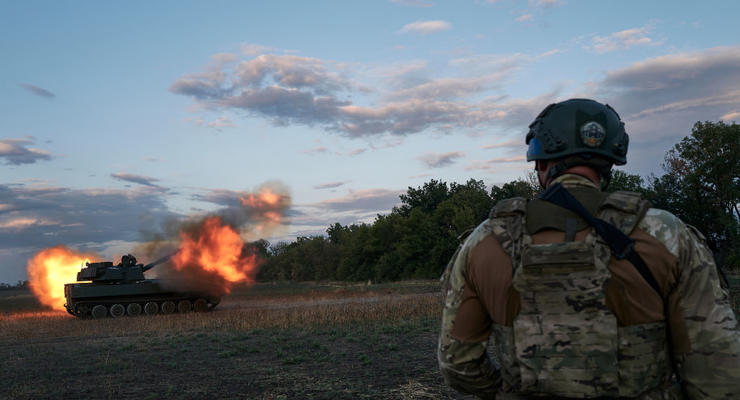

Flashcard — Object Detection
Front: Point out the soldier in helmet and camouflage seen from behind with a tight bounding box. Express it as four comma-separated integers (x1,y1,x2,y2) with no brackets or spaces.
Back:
438,99,740,399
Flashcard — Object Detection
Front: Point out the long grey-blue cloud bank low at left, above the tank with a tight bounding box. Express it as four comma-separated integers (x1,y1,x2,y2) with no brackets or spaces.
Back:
0,185,175,250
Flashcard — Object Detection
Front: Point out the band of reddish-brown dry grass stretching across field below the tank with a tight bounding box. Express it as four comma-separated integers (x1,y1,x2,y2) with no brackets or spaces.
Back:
0,284,442,340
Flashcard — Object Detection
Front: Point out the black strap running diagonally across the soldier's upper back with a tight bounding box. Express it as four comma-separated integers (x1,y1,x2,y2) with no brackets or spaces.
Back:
539,183,663,299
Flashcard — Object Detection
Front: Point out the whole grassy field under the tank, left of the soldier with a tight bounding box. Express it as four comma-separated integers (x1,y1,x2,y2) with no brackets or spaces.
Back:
0,281,471,399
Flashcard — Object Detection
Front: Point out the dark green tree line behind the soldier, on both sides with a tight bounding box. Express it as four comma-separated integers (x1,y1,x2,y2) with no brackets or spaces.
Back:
254,121,740,281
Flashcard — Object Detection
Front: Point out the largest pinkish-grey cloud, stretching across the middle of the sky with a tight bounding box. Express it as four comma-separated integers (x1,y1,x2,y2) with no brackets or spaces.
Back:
170,46,555,138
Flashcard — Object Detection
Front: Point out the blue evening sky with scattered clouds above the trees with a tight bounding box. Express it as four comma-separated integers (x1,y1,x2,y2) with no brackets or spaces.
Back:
0,0,740,283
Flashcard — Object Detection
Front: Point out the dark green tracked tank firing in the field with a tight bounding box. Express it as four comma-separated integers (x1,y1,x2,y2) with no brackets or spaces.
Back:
64,253,221,318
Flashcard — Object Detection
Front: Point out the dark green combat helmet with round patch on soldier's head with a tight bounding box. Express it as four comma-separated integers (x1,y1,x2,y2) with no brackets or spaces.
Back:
527,99,629,165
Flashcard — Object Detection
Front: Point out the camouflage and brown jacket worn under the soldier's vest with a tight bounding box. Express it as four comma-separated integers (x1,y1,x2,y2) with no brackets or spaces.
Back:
438,175,740,399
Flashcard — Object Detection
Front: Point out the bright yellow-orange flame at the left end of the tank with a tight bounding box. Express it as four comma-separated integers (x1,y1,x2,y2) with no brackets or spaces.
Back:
26,246,95,310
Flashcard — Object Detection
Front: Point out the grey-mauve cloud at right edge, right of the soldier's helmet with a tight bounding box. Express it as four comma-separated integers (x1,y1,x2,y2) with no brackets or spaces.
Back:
592,46,740,141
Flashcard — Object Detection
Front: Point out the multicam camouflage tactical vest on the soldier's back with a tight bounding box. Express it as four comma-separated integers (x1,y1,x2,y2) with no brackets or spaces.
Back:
491,192,680,399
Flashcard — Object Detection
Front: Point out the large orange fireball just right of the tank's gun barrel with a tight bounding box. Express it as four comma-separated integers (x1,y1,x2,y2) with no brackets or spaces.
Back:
172,217,258,293
